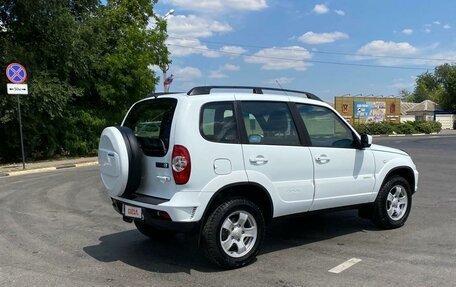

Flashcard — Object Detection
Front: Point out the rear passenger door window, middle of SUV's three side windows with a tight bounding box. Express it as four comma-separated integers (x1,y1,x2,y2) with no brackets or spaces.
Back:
241,101,300,145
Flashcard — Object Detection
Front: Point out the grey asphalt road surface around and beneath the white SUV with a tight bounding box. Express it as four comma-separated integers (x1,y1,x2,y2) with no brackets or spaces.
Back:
0,136,456,287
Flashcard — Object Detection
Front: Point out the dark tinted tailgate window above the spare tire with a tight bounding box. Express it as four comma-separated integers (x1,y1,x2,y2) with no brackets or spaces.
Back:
124,99,177,157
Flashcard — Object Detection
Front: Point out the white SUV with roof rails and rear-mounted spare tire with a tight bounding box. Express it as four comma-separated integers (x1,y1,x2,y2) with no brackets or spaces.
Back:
98,86,418,268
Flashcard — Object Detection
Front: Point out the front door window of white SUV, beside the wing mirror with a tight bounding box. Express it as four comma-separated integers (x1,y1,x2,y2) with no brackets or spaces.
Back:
297,104,354,148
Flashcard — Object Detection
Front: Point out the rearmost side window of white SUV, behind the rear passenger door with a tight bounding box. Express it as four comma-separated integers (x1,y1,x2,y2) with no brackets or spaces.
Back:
200,102,239,143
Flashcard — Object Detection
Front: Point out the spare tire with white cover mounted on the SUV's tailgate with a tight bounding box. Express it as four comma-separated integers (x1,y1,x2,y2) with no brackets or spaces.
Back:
98,127,142,196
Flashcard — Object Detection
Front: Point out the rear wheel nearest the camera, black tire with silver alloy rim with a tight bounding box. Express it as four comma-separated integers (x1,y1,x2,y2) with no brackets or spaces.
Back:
202,199,265,269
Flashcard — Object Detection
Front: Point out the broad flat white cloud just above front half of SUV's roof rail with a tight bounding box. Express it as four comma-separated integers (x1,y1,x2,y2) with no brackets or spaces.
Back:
244,46,312,71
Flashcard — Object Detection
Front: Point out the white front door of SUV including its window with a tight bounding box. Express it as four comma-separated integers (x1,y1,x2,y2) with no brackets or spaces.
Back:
297,104,375,210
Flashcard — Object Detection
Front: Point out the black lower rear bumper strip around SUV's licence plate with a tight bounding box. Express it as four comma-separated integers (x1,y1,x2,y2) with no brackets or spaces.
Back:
111,198,199,233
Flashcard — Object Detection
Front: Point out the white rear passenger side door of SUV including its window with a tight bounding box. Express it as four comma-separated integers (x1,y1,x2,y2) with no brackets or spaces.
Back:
236,99,314,216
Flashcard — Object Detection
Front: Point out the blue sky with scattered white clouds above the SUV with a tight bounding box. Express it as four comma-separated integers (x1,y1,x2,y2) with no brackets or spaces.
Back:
154,0,456,101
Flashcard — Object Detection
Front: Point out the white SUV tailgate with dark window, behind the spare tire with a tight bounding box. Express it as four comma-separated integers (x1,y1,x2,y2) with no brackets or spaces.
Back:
122,98,177,199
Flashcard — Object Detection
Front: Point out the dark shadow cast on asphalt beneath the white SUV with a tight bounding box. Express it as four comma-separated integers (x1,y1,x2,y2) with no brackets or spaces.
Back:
83,211,377,274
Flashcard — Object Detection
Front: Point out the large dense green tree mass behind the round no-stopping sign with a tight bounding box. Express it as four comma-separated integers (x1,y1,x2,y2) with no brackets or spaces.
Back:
0,0,169,162
